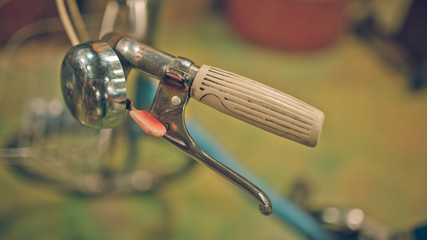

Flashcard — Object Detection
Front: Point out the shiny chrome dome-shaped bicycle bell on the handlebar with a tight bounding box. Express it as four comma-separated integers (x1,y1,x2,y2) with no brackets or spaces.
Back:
61,42,127,129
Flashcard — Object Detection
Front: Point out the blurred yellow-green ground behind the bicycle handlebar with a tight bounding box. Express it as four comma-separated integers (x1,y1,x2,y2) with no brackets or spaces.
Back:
0,0,427,239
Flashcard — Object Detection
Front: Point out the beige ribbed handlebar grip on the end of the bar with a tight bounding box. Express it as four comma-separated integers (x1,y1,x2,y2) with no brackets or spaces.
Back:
190,65,325,147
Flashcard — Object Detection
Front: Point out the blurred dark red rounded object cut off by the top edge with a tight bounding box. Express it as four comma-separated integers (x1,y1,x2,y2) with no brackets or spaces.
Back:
226,0,349,51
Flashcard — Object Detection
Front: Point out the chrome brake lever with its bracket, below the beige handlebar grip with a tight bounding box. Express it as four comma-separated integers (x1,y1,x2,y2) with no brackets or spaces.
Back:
150,83,273,215
